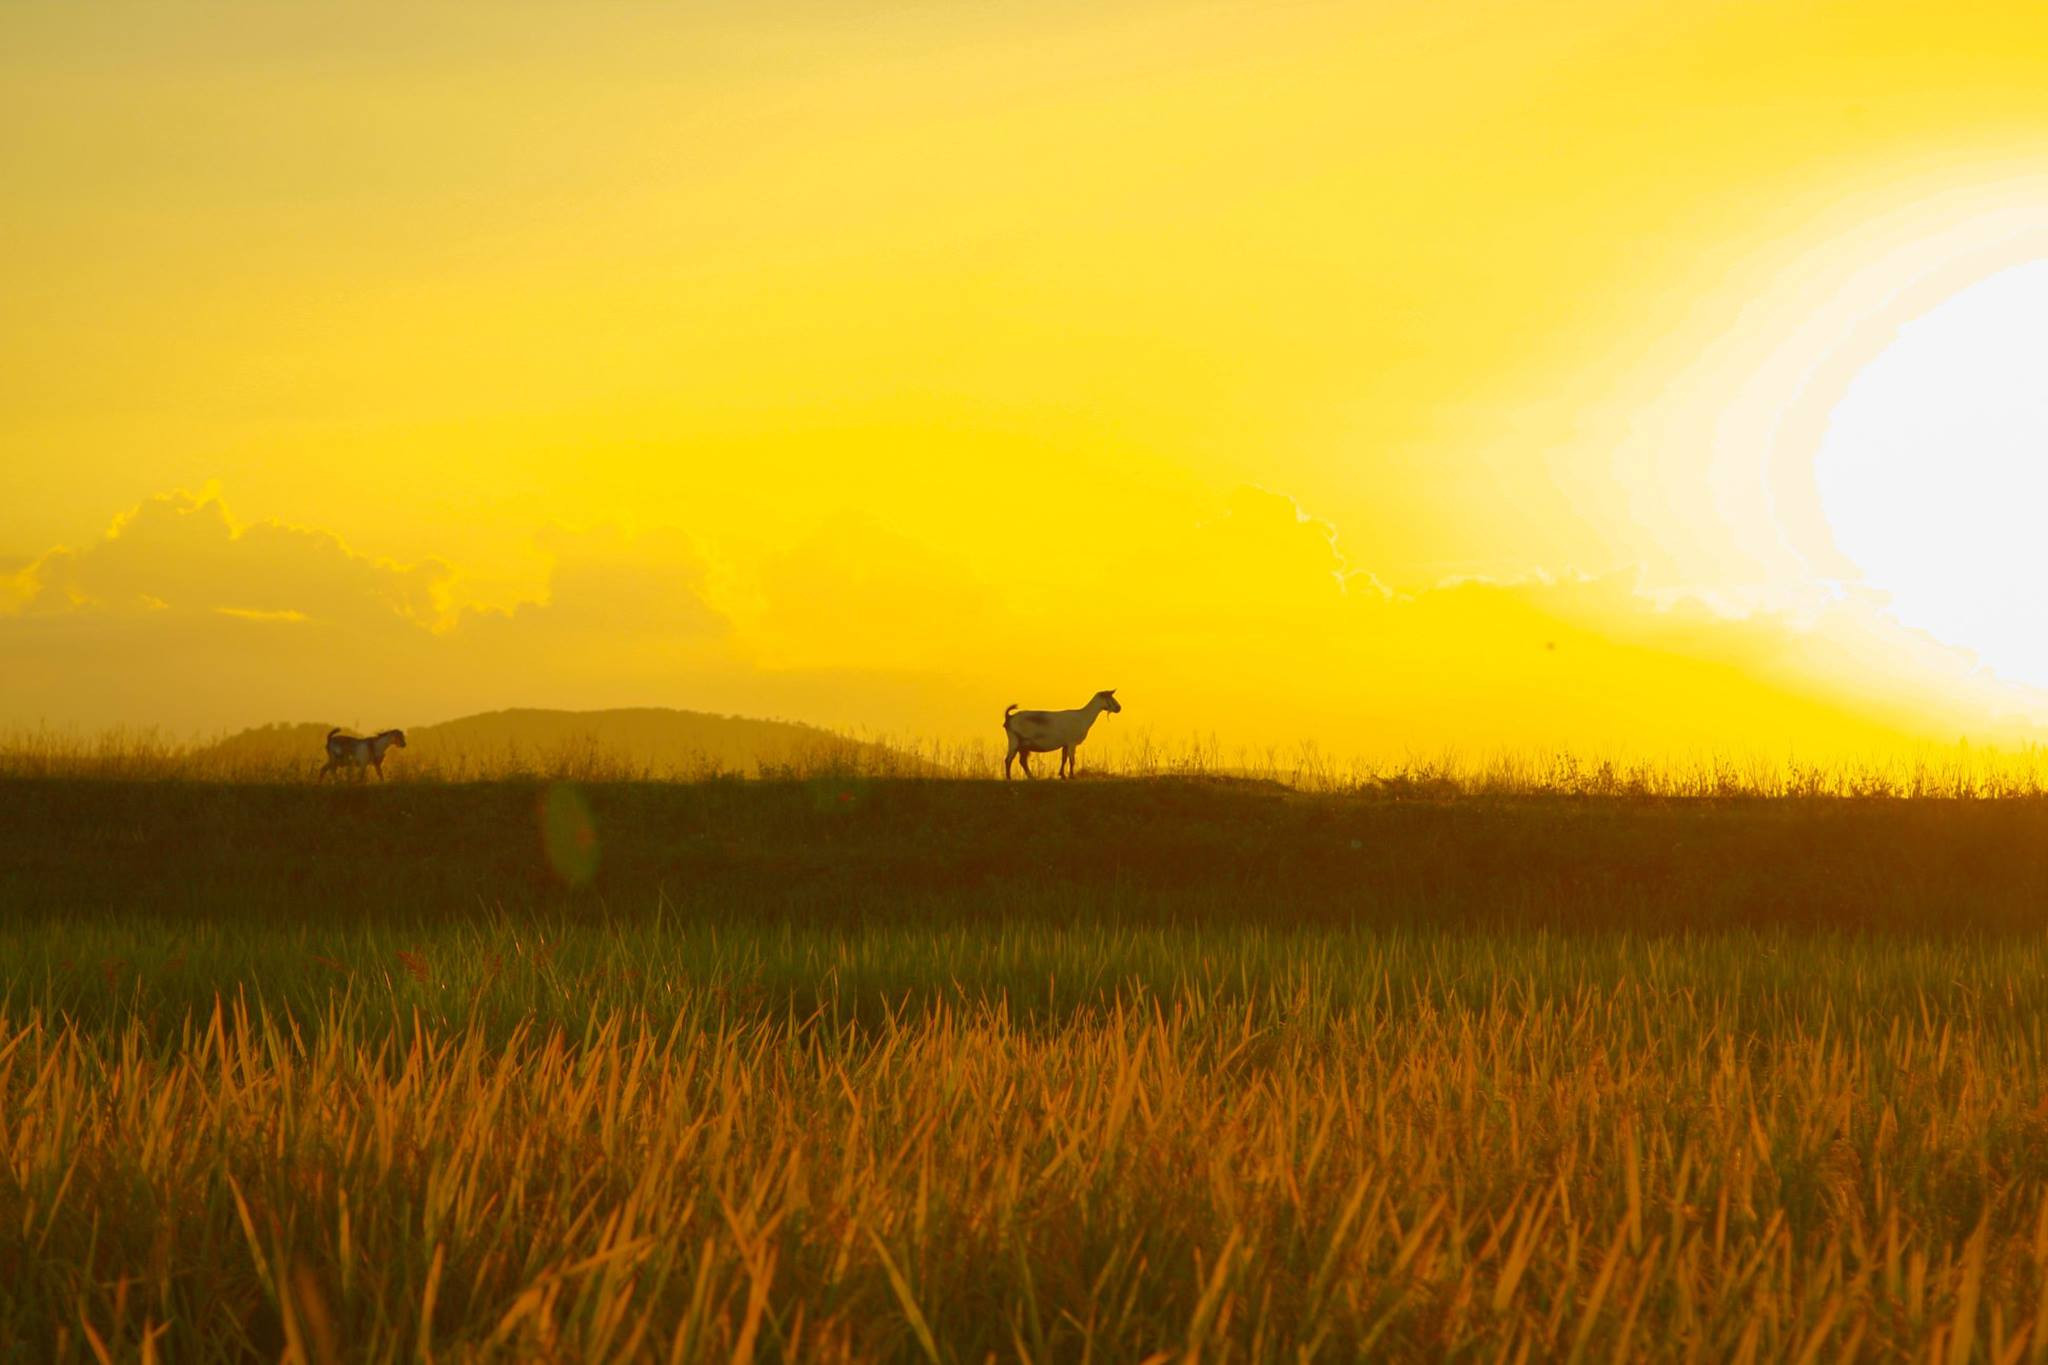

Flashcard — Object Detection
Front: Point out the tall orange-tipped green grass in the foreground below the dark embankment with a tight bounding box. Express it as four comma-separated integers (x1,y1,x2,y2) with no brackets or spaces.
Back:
12,921,2048,1361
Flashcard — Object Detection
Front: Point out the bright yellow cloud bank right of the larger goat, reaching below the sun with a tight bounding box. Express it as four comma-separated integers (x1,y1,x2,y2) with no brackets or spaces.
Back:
1040,487,2048,757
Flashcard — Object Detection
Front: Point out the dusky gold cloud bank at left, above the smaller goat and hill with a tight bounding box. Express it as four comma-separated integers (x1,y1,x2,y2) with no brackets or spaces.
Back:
0,493,729,726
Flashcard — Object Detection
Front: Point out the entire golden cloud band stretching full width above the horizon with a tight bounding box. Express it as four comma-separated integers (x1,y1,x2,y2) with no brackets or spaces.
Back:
0,487,2048,753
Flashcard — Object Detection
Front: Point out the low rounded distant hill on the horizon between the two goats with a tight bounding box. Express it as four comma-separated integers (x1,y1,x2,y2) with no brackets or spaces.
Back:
195,706,932,778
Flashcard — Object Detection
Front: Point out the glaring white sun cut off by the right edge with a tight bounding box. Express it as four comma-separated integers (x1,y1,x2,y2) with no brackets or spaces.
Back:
1815,260,2048,686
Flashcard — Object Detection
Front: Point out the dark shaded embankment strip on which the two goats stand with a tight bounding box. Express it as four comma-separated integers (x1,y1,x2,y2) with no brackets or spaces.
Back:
0,780,2048,931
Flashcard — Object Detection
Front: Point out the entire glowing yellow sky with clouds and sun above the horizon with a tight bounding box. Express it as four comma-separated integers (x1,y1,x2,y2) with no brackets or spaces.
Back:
0,0,2048,755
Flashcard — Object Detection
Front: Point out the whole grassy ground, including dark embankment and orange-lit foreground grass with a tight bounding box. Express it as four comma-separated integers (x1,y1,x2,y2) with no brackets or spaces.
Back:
12,776,2048,1361
